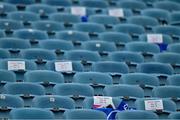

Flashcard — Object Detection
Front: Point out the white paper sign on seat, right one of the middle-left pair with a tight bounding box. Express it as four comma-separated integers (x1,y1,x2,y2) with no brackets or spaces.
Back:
55,61,73,72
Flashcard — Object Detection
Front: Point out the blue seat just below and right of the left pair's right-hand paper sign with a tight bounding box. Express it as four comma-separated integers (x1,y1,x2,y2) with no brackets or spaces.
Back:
73,72,113,95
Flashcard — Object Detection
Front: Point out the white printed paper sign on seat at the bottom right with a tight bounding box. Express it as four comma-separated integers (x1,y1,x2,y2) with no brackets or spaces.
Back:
144,100,164,110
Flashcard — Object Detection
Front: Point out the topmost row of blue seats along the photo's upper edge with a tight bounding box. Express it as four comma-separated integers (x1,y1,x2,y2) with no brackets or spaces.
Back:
1,0,179,11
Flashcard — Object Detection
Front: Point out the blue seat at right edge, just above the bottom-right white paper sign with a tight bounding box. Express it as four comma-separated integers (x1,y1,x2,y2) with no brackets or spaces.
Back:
152,85,180,111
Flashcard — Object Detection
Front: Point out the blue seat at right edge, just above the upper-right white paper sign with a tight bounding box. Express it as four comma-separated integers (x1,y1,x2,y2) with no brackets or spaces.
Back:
153,25,180,42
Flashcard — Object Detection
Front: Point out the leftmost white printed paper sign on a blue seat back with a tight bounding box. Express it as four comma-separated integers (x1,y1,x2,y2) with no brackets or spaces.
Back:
8,61,25,70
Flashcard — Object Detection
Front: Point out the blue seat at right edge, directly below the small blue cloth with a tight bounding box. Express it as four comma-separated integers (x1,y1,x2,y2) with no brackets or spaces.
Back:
154,52,180,74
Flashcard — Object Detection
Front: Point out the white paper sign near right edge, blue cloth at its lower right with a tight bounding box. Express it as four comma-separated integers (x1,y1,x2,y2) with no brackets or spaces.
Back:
147,34,163,43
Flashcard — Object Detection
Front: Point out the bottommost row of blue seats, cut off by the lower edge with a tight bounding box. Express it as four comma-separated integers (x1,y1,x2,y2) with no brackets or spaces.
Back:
7,108,179,120
